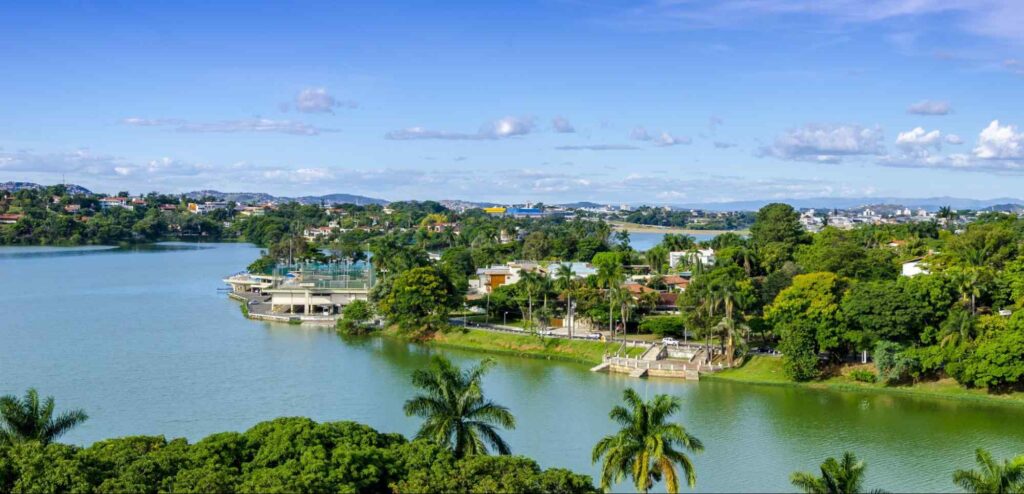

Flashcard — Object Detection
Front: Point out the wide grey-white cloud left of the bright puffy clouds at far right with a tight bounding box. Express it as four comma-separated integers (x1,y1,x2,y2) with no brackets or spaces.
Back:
757,125,885,163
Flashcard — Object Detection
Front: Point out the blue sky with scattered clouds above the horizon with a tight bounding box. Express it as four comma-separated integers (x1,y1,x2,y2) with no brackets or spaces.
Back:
6,0,1024,204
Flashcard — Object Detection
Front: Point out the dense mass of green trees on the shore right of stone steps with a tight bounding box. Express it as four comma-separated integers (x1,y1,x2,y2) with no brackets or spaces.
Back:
680,204,1024,392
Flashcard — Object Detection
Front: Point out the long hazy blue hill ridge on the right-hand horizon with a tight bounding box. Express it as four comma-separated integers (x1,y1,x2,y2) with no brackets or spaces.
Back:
673,197,1024,211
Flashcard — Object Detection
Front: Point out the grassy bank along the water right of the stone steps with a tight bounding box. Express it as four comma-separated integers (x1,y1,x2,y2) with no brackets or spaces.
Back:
700,357,1024,406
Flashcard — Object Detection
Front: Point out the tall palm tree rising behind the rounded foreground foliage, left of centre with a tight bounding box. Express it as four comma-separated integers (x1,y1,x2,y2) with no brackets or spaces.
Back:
404,357,515,458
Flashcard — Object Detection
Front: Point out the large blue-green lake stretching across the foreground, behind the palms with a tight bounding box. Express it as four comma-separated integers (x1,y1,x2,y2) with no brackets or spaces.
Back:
0,240,1024,492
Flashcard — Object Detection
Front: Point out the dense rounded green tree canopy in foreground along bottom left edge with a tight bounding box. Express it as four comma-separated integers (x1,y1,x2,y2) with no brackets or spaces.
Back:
0,417,595,493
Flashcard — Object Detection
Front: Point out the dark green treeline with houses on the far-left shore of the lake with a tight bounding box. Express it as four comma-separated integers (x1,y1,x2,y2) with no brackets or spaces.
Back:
0,186,231,245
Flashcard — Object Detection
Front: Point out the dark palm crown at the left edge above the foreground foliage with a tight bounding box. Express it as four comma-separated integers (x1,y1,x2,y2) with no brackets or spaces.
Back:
0,388,89,444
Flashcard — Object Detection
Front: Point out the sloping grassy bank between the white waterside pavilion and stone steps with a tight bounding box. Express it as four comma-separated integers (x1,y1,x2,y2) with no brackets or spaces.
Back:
415,328,643,365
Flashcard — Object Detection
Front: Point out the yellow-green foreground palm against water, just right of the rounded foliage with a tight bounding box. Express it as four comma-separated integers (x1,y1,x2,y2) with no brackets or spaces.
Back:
591,389,703,493
